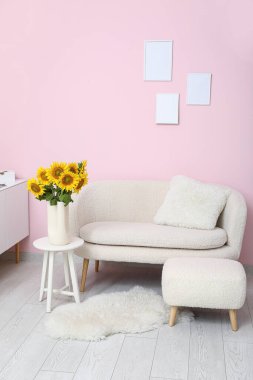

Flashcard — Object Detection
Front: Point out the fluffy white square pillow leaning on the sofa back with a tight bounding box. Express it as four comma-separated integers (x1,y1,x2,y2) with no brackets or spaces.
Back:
154,176,228,230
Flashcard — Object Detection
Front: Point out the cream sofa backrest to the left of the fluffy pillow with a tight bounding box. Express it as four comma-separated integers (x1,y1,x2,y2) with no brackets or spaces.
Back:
75,181,169,226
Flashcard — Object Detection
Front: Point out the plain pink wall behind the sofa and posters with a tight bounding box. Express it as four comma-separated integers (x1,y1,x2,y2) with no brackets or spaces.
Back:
0,0,253,264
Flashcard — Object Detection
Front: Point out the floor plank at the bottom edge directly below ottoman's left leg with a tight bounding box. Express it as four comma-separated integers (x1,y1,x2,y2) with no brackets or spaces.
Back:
151,323,190,379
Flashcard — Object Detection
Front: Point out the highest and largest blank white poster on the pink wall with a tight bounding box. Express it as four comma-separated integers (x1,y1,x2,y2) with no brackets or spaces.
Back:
144,41,172,81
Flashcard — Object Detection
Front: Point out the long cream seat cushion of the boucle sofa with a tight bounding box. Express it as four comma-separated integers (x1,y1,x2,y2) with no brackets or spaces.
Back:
80,222,227,249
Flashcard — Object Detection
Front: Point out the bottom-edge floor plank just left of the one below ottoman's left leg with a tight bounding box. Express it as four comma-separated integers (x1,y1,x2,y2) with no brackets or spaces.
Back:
112,337,156,380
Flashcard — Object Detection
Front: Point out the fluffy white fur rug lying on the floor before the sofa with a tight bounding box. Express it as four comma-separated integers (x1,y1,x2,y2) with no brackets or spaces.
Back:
46,286,193,341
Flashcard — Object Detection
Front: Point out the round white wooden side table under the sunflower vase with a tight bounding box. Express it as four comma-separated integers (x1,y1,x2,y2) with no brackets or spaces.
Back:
33,237,84,313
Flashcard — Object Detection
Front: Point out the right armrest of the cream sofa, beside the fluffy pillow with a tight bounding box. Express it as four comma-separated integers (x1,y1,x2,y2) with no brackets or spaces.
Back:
217,191,247,259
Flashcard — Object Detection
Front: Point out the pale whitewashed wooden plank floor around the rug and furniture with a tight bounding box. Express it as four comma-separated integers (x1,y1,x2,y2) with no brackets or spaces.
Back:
0,254,253,380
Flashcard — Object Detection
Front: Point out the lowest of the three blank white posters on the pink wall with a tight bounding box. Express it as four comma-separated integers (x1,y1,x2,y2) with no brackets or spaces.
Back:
156,94,179,124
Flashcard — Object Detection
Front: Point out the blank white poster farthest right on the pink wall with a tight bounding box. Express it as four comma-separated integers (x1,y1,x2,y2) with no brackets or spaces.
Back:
187,73,212,105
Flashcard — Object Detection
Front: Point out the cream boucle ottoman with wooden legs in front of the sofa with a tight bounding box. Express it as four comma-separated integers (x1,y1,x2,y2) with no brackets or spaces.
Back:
162,257,246,331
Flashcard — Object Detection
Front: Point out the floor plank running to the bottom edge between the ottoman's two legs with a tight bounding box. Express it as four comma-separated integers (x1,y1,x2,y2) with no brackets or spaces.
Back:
188,311,226,380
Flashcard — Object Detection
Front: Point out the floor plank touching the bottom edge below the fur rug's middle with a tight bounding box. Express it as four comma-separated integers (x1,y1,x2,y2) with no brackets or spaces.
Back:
74,334,124,380
